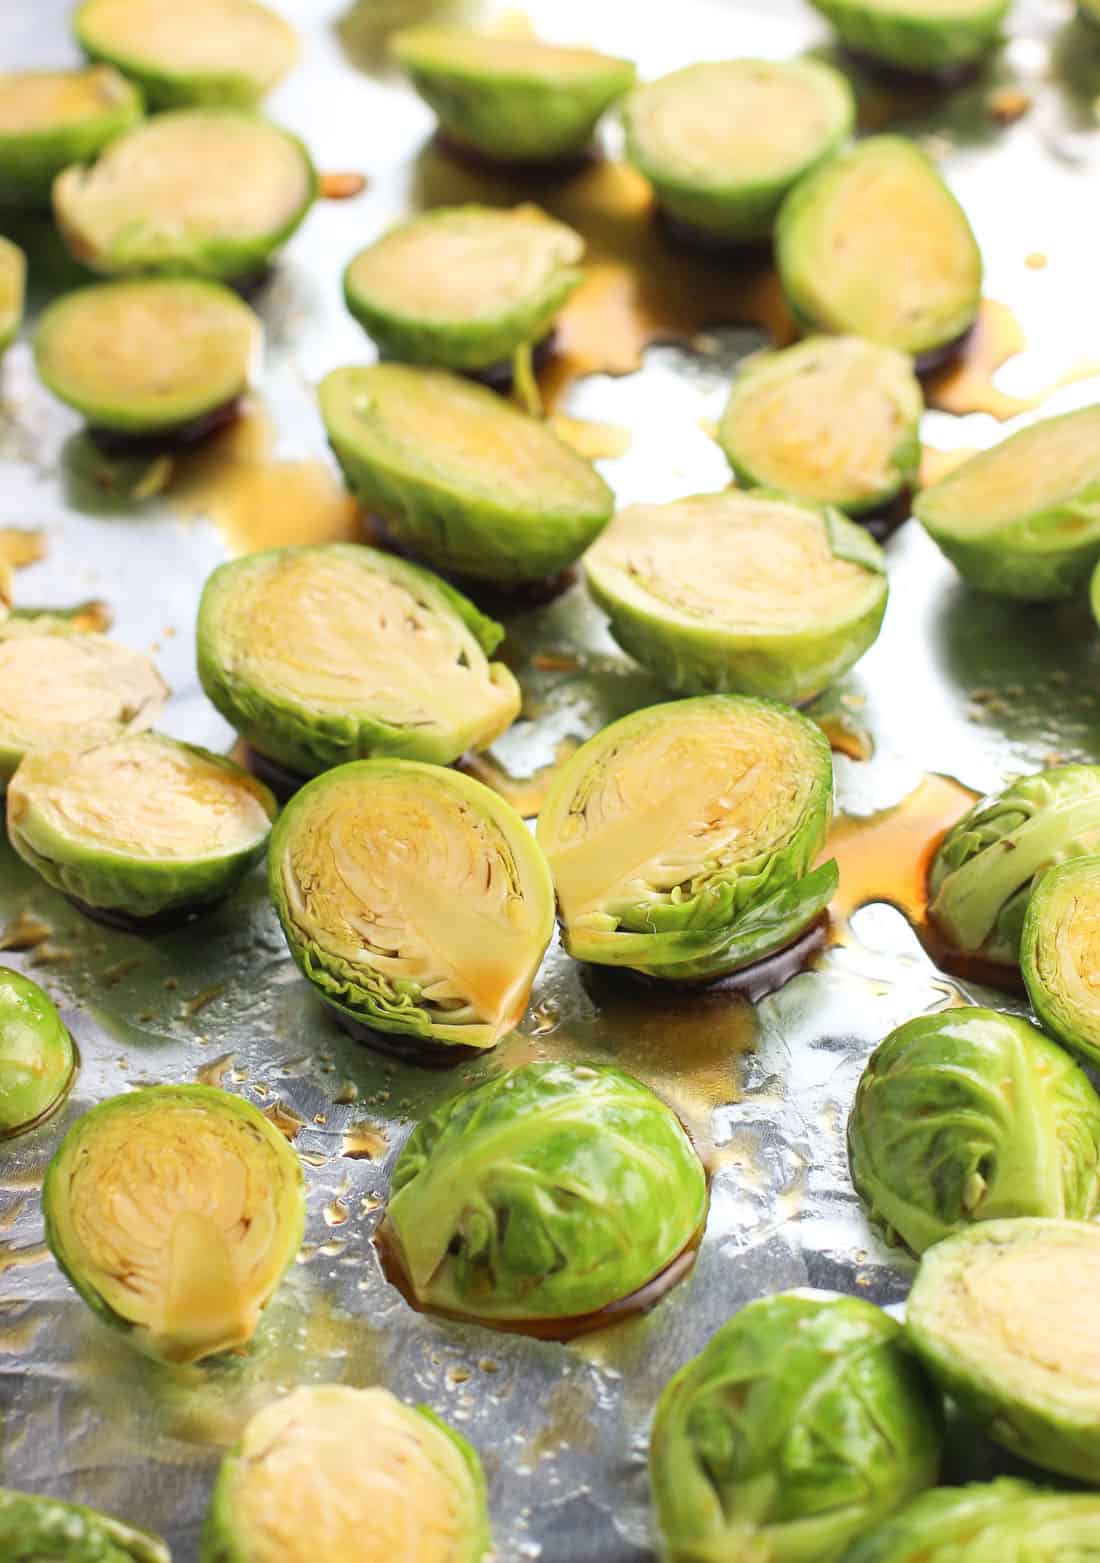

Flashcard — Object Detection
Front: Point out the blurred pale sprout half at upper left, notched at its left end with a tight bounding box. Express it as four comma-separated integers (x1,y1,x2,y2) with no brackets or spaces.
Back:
53,108,317,281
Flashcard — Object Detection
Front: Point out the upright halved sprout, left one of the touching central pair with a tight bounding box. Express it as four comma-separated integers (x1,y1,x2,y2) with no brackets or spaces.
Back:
267,760,553,1047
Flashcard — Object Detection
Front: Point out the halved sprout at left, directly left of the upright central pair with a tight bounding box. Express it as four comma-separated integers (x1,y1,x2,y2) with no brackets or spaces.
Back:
8,733,275,921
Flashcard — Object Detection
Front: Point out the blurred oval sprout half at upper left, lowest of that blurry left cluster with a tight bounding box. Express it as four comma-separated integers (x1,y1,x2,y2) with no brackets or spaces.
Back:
34,277,263,435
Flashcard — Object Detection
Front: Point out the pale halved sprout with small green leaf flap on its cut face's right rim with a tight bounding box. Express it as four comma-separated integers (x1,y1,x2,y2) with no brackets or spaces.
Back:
584,489,888,702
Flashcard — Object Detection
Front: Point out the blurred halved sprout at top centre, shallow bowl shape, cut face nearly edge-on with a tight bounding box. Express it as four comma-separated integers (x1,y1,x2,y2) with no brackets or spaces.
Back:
391,25,634,163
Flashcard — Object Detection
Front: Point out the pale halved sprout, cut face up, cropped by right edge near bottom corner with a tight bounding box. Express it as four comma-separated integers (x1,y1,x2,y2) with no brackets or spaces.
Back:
906,1218,1100,1485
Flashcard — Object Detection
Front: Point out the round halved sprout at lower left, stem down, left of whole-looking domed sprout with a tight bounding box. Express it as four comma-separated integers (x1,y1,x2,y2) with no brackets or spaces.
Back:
42,1085,305,1363
